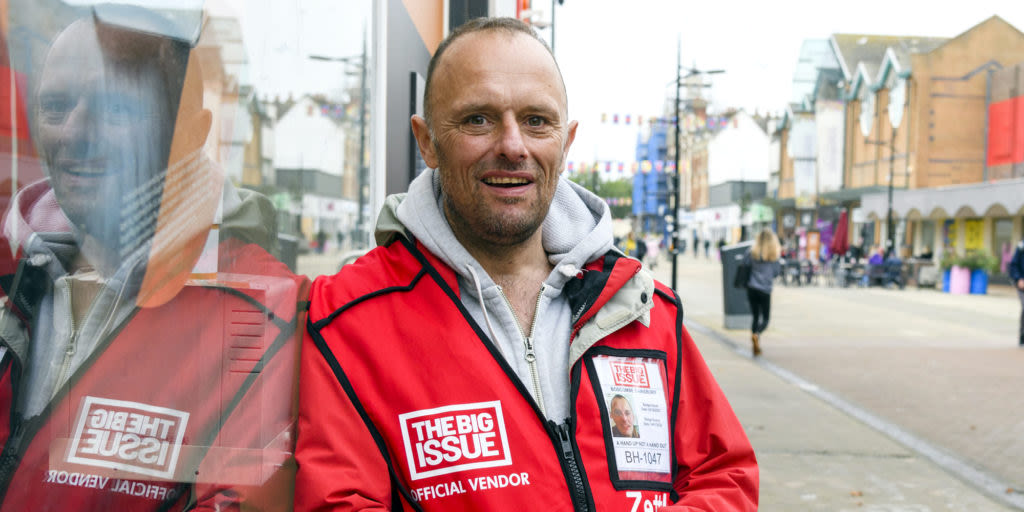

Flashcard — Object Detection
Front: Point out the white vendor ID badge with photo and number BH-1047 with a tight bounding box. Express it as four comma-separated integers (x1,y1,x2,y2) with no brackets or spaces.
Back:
592,354,672,482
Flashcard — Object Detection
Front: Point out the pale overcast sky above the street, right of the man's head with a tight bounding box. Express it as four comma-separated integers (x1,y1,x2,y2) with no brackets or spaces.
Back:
552,0,1024,162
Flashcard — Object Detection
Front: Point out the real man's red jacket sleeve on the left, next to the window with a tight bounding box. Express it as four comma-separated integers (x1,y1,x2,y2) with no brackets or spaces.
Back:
295,321,391,512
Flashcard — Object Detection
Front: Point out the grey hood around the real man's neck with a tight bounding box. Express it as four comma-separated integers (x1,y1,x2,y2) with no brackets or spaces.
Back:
376,169,612,288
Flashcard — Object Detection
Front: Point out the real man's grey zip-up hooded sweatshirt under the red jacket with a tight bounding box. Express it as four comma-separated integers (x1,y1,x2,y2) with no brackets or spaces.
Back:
377,170,612,422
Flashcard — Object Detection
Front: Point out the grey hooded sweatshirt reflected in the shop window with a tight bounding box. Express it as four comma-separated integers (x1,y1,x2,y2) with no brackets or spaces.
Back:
0,174,276,418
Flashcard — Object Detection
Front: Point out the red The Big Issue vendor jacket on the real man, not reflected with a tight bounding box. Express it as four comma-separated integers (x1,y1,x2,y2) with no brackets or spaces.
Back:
296,240,757,511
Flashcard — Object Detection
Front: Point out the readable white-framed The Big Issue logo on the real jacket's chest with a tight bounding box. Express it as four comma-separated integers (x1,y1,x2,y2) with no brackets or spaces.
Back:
398,400,512,480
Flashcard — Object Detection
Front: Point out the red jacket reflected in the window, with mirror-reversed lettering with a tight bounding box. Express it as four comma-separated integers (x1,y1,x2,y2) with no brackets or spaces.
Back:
0,241,307,510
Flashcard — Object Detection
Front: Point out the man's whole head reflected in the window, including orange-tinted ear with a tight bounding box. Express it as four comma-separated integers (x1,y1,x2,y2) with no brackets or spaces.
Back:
33,8,209,254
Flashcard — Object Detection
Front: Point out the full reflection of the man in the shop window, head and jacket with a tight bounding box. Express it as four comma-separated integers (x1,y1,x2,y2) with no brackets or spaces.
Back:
0,5,304,510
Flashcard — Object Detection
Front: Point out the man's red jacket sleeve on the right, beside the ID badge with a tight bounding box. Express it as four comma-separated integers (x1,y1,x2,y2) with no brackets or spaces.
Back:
658,328,758,512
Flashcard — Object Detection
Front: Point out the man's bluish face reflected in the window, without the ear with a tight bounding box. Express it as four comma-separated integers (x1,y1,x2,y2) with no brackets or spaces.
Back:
35,22,170,247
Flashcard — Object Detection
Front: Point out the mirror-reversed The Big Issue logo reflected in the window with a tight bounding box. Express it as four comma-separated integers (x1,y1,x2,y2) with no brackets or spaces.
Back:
67,396,188,478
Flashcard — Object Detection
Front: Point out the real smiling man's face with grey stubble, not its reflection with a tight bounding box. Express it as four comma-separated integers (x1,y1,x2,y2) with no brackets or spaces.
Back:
414,32,575,248
